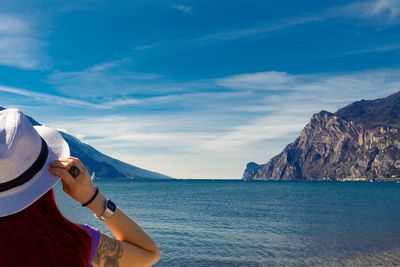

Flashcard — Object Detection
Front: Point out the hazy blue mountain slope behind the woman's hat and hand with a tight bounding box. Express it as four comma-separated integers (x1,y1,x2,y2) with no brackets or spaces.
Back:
0,107,172,179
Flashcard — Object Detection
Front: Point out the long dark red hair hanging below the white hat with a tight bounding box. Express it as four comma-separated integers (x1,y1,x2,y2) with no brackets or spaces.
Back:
0,189,91,267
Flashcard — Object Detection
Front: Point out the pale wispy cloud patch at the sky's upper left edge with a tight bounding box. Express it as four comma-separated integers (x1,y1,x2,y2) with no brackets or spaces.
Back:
0,13,45,69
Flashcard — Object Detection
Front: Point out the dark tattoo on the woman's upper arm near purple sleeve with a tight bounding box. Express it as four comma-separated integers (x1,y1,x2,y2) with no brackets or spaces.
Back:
93,233,124,267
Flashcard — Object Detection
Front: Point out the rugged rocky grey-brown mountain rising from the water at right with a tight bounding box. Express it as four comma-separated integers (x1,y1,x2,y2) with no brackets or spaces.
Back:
243,92,400,180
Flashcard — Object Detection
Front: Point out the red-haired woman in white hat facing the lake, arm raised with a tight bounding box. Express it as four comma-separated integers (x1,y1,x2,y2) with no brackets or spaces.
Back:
0,109,160,267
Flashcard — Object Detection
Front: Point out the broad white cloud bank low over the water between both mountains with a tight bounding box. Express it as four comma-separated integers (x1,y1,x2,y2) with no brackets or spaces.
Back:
38,69,400,178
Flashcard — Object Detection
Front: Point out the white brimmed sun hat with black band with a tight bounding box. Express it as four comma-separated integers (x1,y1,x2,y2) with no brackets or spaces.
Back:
0,108,70,217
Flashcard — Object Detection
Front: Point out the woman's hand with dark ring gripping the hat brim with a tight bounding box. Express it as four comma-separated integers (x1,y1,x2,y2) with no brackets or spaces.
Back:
49,157,96,204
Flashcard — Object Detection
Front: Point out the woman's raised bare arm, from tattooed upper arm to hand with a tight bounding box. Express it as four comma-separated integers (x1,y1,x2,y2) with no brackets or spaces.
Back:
49,157,160,267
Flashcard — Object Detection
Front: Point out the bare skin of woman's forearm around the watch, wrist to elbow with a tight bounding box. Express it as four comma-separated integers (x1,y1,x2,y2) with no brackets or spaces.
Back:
87,189,159,253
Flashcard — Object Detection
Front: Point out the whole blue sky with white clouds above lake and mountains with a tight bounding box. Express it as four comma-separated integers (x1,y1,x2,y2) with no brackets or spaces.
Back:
0,0,400,178
